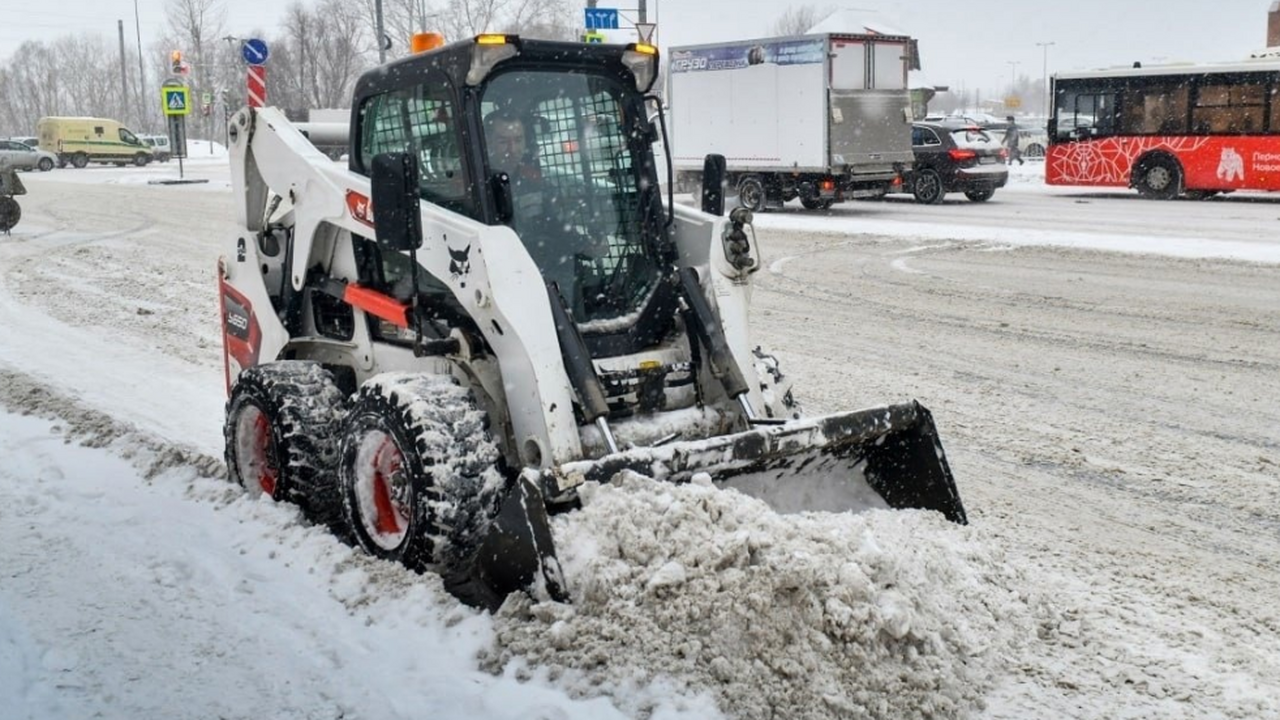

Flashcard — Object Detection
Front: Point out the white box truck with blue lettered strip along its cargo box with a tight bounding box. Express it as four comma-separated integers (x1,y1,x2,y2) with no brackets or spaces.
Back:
667,33,915,211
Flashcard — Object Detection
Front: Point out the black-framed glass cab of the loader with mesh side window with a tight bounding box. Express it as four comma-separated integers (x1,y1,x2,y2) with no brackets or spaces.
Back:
349,36,675,354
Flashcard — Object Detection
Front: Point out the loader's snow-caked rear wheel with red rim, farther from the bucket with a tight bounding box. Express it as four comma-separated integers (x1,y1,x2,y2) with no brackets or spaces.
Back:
223,360,343,517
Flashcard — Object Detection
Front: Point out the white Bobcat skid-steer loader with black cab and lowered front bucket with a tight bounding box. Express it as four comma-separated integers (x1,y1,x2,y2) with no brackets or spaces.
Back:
219,35,965,609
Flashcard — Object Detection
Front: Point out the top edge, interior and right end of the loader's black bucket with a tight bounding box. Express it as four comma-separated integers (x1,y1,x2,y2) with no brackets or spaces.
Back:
555,401,968,524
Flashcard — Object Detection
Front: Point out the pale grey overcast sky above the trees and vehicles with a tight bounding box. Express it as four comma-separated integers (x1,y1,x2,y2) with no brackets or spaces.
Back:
0,0,1271,91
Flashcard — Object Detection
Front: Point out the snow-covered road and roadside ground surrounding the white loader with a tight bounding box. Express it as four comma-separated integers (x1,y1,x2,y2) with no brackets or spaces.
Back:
0,163,1280,720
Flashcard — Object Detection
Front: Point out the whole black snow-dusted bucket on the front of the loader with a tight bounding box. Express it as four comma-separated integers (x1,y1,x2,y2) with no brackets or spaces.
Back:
445,401,968,610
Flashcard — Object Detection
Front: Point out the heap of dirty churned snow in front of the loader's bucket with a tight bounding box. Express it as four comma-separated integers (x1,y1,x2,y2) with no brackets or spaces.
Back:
484,475,1038,720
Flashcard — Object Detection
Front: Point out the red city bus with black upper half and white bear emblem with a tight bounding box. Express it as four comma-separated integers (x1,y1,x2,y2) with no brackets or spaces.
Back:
1044,58,1280,199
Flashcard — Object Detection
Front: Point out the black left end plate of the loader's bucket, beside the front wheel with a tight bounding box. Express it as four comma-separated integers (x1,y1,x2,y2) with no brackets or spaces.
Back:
443,475,568,612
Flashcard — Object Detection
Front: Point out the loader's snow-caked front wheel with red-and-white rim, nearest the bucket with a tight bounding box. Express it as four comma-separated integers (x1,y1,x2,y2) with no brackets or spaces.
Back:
338,373,508,574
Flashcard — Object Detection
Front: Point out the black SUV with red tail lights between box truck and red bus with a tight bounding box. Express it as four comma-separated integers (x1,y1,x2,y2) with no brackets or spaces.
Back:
902,123,1009,205
